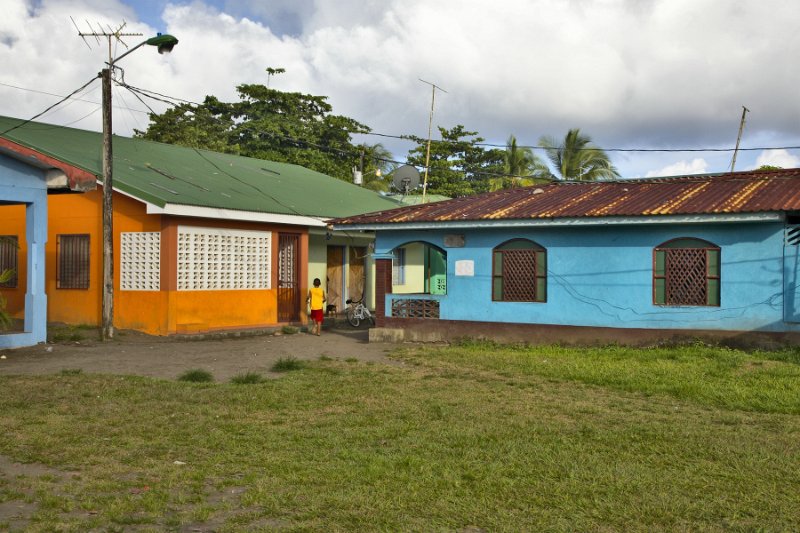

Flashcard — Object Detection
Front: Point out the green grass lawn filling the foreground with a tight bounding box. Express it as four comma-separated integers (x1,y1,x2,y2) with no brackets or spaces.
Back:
0,344,800,531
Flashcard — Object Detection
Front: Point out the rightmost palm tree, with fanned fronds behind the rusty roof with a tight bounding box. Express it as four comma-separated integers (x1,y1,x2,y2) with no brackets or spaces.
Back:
539,128,620,181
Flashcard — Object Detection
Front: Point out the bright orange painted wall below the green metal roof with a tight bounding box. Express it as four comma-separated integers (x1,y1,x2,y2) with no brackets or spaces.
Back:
0,187,308,335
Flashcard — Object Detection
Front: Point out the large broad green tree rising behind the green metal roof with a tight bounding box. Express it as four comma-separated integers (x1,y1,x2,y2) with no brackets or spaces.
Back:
136,69,382,181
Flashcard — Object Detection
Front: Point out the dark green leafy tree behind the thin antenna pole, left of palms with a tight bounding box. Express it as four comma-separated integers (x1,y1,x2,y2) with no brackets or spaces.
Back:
405,124,503,197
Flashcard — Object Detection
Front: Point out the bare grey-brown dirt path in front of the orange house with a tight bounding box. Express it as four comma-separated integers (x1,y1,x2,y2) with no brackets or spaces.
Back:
0,326,397,381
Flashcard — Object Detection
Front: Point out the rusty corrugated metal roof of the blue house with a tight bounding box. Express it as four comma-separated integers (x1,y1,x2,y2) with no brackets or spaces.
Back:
331,168,800,226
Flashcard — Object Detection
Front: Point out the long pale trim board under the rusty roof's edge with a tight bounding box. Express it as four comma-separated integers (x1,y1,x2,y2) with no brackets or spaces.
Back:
333,213,783,231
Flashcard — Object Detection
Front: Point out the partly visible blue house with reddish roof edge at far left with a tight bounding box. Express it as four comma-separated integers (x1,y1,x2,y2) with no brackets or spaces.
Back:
0,130,96,348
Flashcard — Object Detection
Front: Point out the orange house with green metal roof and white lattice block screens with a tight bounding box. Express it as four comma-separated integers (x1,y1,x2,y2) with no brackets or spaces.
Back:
0,117,395,335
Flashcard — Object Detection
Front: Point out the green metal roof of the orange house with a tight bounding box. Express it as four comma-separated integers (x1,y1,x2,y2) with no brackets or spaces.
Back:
0,116,397,218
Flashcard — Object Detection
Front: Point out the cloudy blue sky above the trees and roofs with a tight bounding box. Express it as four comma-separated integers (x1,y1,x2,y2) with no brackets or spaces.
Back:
0,0,800,177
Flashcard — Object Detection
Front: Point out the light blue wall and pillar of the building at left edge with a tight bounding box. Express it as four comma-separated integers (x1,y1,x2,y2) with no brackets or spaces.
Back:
0,155,47,348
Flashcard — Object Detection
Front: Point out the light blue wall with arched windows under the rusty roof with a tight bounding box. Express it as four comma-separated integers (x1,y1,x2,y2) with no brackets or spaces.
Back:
375,222,800,331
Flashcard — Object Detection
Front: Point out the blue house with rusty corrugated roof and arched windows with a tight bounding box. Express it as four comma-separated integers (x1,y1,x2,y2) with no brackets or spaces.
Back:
332,169,800,343
